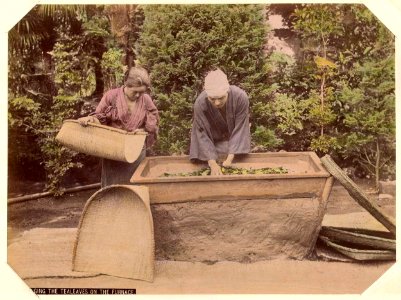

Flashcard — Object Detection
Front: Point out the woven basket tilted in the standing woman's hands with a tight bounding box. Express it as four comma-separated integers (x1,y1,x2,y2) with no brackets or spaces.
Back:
56,120,147,163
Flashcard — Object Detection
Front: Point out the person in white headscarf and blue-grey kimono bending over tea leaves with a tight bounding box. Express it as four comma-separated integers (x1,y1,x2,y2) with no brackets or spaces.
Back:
189,69,251,175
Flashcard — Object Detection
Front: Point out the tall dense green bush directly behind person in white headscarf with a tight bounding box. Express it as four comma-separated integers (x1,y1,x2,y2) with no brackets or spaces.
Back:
138,5,274,154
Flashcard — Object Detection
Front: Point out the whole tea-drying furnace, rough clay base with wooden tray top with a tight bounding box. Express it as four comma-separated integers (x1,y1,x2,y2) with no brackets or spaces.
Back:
131,152,333,263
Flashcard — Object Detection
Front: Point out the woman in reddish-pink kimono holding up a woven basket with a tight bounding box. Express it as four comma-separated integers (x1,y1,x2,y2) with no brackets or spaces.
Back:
78,67,159,187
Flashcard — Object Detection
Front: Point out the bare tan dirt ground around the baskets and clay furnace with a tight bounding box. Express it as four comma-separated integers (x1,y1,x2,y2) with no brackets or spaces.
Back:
7,181,400,294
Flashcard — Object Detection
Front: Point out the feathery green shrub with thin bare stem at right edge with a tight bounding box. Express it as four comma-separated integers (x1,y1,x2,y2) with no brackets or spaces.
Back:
340,55,395,185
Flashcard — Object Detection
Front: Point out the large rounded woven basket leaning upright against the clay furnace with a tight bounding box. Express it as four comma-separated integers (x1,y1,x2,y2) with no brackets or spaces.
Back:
72,185,155,282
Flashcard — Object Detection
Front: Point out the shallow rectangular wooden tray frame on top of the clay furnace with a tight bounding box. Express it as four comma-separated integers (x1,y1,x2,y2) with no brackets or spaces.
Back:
131,152,330,204
